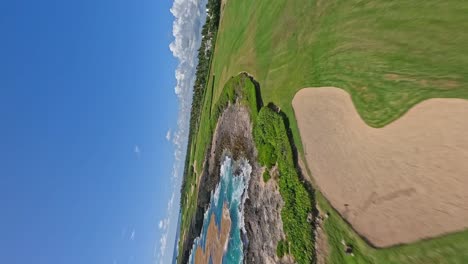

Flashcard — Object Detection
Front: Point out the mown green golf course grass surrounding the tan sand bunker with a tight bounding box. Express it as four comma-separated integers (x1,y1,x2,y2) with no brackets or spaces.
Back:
204,0,468,263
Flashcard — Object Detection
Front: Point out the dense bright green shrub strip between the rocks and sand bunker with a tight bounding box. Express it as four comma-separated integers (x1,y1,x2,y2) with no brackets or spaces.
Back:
253,107,315,263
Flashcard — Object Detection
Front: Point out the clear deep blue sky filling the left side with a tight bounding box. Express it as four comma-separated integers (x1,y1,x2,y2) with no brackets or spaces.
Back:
0,0,206,264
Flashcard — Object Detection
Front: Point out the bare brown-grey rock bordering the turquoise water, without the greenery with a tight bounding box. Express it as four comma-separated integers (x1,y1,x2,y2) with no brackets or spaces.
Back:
182,100,293,263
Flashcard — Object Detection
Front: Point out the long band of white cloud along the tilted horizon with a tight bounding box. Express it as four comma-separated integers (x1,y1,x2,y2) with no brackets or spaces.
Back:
157,0,207,263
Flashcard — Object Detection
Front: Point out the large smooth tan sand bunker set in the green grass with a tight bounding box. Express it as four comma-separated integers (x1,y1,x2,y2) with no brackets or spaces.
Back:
293,87,468,247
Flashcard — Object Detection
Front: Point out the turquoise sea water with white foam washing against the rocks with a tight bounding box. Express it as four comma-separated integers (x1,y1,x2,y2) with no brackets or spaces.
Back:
189,157,252,264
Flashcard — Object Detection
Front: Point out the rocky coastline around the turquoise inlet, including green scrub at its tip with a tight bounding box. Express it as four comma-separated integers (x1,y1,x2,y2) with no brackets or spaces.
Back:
179,73,300,263
